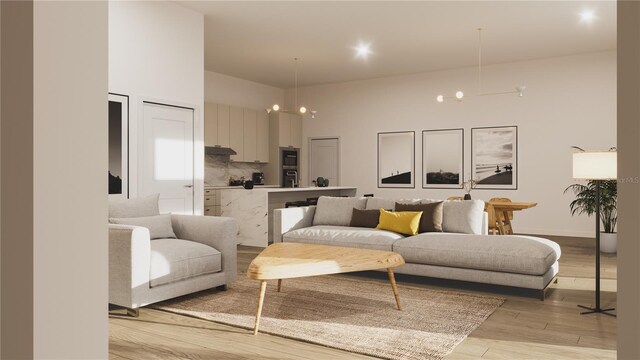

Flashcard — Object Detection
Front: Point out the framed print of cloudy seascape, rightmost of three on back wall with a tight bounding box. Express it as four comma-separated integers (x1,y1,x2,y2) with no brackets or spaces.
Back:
471,126,518,190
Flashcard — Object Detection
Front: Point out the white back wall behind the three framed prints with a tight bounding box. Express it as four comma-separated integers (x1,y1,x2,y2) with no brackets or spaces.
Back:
286,51,616,236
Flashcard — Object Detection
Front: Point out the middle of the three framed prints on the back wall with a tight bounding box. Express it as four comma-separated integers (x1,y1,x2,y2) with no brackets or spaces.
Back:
422,129,464,189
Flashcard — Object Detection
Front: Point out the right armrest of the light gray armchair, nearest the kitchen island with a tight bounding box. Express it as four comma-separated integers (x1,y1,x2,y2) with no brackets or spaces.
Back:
171,215,238,284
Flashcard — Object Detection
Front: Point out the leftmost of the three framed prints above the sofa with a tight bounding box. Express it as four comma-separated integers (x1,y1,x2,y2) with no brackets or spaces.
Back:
378,131,415,188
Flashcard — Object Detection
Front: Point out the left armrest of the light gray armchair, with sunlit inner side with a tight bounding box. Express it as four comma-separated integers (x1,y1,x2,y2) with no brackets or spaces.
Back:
109,224,151,308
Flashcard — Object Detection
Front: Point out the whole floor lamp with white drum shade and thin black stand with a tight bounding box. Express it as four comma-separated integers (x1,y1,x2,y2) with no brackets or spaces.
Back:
573,151,618,316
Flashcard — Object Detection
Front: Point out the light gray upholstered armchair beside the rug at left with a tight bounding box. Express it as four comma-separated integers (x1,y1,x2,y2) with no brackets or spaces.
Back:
109,195,238,316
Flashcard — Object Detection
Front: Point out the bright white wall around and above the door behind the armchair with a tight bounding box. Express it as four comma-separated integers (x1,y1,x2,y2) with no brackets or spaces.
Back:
109,1,204,214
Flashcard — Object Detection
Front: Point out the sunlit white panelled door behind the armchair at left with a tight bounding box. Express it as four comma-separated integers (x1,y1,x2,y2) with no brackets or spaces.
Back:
140,102,194,215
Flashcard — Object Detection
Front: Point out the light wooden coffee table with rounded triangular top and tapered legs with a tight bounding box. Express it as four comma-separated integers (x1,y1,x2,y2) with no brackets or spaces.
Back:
247,243,404,335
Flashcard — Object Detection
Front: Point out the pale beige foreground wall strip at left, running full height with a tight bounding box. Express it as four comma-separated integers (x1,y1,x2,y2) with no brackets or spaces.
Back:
34,1,109,359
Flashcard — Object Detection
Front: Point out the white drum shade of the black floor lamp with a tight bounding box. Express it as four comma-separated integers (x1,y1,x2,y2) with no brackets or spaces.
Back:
573,151,618,180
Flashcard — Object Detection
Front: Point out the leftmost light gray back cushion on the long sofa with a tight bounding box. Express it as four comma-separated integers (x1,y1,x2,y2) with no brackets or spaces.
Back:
313,196,367,226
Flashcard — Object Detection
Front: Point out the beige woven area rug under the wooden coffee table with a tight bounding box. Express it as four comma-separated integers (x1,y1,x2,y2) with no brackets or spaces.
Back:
152,275,504,359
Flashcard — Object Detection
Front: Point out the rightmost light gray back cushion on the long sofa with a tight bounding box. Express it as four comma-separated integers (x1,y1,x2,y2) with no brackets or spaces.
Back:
442,200,484,234
